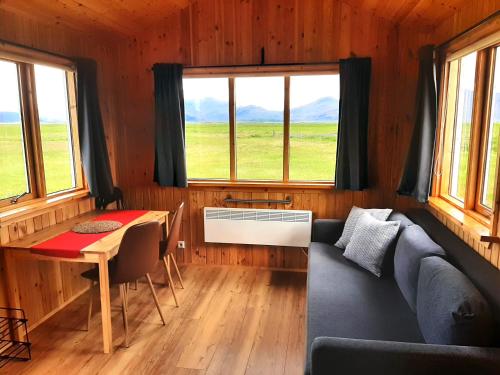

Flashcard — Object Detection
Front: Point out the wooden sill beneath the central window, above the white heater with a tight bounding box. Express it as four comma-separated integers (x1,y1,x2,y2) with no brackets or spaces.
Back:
188,180,335,190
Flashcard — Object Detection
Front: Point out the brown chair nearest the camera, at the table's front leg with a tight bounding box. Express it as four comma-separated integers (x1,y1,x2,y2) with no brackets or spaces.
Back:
82,221,165,347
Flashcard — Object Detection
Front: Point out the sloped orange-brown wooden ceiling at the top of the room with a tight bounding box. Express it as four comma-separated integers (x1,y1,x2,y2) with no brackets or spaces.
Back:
0,0,474,36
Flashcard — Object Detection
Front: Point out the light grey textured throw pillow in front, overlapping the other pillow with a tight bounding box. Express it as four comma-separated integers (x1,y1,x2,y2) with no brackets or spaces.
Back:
344,213,400,277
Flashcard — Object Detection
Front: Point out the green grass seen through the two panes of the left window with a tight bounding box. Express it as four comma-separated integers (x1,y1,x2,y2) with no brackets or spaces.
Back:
0,124,73,199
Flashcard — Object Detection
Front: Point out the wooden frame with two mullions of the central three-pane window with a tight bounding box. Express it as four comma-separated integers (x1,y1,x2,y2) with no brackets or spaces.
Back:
183,64,340,189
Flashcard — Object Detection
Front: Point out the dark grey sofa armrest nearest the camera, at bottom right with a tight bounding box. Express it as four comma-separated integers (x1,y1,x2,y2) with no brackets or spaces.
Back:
311,337,500,375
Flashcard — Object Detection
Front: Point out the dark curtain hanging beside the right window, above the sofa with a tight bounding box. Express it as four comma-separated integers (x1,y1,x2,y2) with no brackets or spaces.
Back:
398,45,437,203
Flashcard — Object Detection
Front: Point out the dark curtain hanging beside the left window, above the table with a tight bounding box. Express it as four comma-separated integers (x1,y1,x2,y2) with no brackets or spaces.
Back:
75,58,113,199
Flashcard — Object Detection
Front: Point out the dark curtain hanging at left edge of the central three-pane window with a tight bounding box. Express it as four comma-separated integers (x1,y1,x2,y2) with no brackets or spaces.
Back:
153,64,187,187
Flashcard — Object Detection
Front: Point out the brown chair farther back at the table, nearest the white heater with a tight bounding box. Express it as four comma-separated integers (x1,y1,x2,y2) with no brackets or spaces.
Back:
160,202,184,307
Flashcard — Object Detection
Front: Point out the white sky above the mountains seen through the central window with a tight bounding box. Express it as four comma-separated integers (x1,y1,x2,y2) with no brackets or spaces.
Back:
183,75,340,111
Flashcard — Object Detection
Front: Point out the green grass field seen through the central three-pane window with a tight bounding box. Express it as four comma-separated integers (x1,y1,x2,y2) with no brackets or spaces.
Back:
186,123,337,181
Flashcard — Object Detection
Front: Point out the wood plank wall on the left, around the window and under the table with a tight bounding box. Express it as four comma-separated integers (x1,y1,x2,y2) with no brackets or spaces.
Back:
0,10,118,327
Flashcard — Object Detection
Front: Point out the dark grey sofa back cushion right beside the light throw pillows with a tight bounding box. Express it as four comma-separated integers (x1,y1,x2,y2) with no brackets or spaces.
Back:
394,225,445,311
